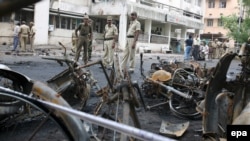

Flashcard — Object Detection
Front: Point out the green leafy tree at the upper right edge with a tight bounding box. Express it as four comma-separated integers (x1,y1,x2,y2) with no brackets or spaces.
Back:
221,0,250,43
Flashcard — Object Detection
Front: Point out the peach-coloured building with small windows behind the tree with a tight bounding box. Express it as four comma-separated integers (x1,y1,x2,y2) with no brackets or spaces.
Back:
201,0,240,41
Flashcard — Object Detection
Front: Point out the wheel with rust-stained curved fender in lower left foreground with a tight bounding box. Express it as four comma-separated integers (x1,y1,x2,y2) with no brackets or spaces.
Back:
0,64,89,141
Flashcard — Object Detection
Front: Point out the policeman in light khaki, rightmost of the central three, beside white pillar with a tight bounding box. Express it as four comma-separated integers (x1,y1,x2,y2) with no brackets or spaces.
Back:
121,12,141,72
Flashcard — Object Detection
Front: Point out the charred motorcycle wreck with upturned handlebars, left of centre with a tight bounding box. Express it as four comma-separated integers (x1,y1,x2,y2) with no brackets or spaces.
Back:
42,42,99,110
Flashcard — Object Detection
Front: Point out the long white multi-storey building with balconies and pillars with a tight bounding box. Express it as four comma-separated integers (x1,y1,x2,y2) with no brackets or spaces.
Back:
0,0,205,51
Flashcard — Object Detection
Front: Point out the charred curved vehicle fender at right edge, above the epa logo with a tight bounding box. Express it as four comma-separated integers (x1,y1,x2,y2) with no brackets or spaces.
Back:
200,41,250,140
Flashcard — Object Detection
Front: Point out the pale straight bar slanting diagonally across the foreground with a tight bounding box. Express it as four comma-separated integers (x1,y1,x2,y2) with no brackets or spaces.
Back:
0,87,175,141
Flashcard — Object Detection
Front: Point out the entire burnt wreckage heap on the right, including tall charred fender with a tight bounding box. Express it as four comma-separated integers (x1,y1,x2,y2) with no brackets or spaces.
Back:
142,41,250,140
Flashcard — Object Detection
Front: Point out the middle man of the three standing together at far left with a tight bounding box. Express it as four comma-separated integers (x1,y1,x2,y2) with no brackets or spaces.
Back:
19,21,30,52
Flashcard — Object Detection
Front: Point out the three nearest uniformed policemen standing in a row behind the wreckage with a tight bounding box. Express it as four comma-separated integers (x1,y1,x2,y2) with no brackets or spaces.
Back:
72,12,141,72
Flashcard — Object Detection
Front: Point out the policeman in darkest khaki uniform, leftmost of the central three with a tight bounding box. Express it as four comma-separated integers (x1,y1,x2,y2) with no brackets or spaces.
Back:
75,15,92,65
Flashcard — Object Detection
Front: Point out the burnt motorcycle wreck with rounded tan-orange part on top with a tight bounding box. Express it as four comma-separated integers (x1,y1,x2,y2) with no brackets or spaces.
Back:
141,54,212,119
